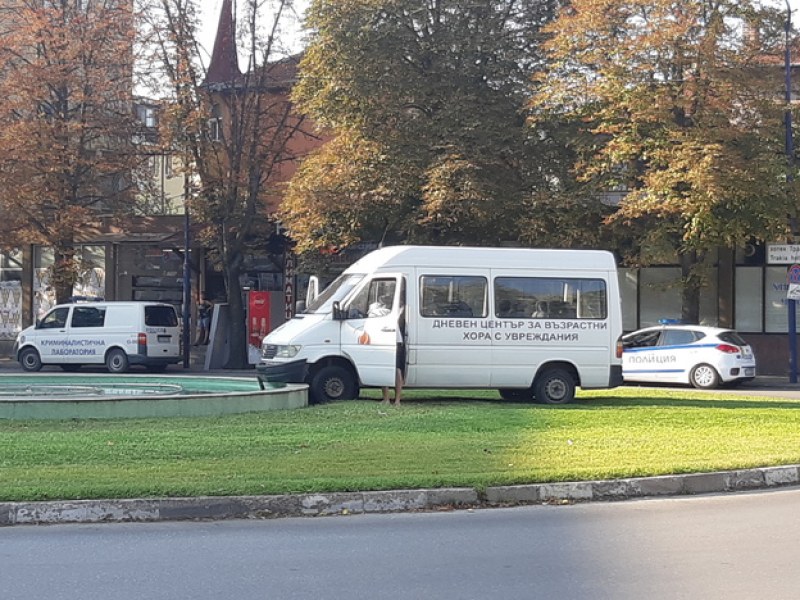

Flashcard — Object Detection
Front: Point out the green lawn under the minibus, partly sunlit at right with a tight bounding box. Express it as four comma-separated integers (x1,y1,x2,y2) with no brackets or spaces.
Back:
0,388,800,500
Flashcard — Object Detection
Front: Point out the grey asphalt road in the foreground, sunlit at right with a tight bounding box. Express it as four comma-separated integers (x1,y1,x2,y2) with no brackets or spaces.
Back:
0,488,800,600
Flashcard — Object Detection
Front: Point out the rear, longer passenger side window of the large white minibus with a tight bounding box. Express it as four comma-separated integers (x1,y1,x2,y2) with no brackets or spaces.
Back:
494,277,608,319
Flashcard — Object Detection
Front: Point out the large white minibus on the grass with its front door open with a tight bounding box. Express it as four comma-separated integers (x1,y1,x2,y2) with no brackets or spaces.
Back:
257,246,622,404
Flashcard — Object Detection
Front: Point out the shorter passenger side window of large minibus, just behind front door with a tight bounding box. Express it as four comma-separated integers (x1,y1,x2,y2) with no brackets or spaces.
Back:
419,275,488,317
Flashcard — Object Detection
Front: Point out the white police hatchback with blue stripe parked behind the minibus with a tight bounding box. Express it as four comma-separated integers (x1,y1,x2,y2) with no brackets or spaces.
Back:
622,325,756,389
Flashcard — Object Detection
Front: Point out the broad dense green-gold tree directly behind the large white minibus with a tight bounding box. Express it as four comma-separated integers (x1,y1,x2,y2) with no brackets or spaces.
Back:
282,0,588,250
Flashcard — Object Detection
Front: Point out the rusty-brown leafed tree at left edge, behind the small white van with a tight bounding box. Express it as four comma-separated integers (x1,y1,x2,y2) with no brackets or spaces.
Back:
0,0,139,301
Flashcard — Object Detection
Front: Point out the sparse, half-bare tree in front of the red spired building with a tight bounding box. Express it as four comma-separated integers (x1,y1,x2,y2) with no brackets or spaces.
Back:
144,0,305,368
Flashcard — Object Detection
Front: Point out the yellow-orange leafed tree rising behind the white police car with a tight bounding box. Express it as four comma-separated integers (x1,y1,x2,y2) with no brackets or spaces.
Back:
531,0,797,322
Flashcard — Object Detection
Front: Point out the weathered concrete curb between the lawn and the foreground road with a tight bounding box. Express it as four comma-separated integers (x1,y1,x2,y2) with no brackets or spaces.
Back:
0,465,800,526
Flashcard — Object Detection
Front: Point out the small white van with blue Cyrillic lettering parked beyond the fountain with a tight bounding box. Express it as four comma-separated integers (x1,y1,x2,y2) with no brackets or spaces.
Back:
14,302,183,373
